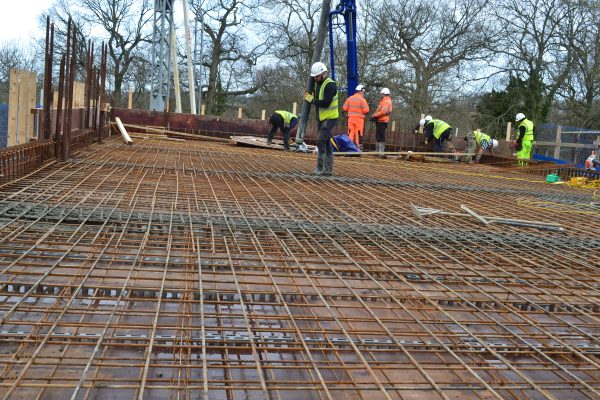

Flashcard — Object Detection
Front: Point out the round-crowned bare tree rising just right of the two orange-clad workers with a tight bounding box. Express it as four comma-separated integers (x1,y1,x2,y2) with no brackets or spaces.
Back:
372,0,491,113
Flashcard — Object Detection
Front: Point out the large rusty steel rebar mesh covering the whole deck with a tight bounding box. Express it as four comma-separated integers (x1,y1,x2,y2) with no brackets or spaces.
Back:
0,137,600,400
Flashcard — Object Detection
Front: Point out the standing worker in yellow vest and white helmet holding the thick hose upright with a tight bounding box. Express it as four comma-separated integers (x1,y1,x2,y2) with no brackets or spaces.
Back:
304,62,340,176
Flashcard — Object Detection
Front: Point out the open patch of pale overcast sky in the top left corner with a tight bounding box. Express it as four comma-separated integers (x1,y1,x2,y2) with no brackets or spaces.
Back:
0,0,52,45
